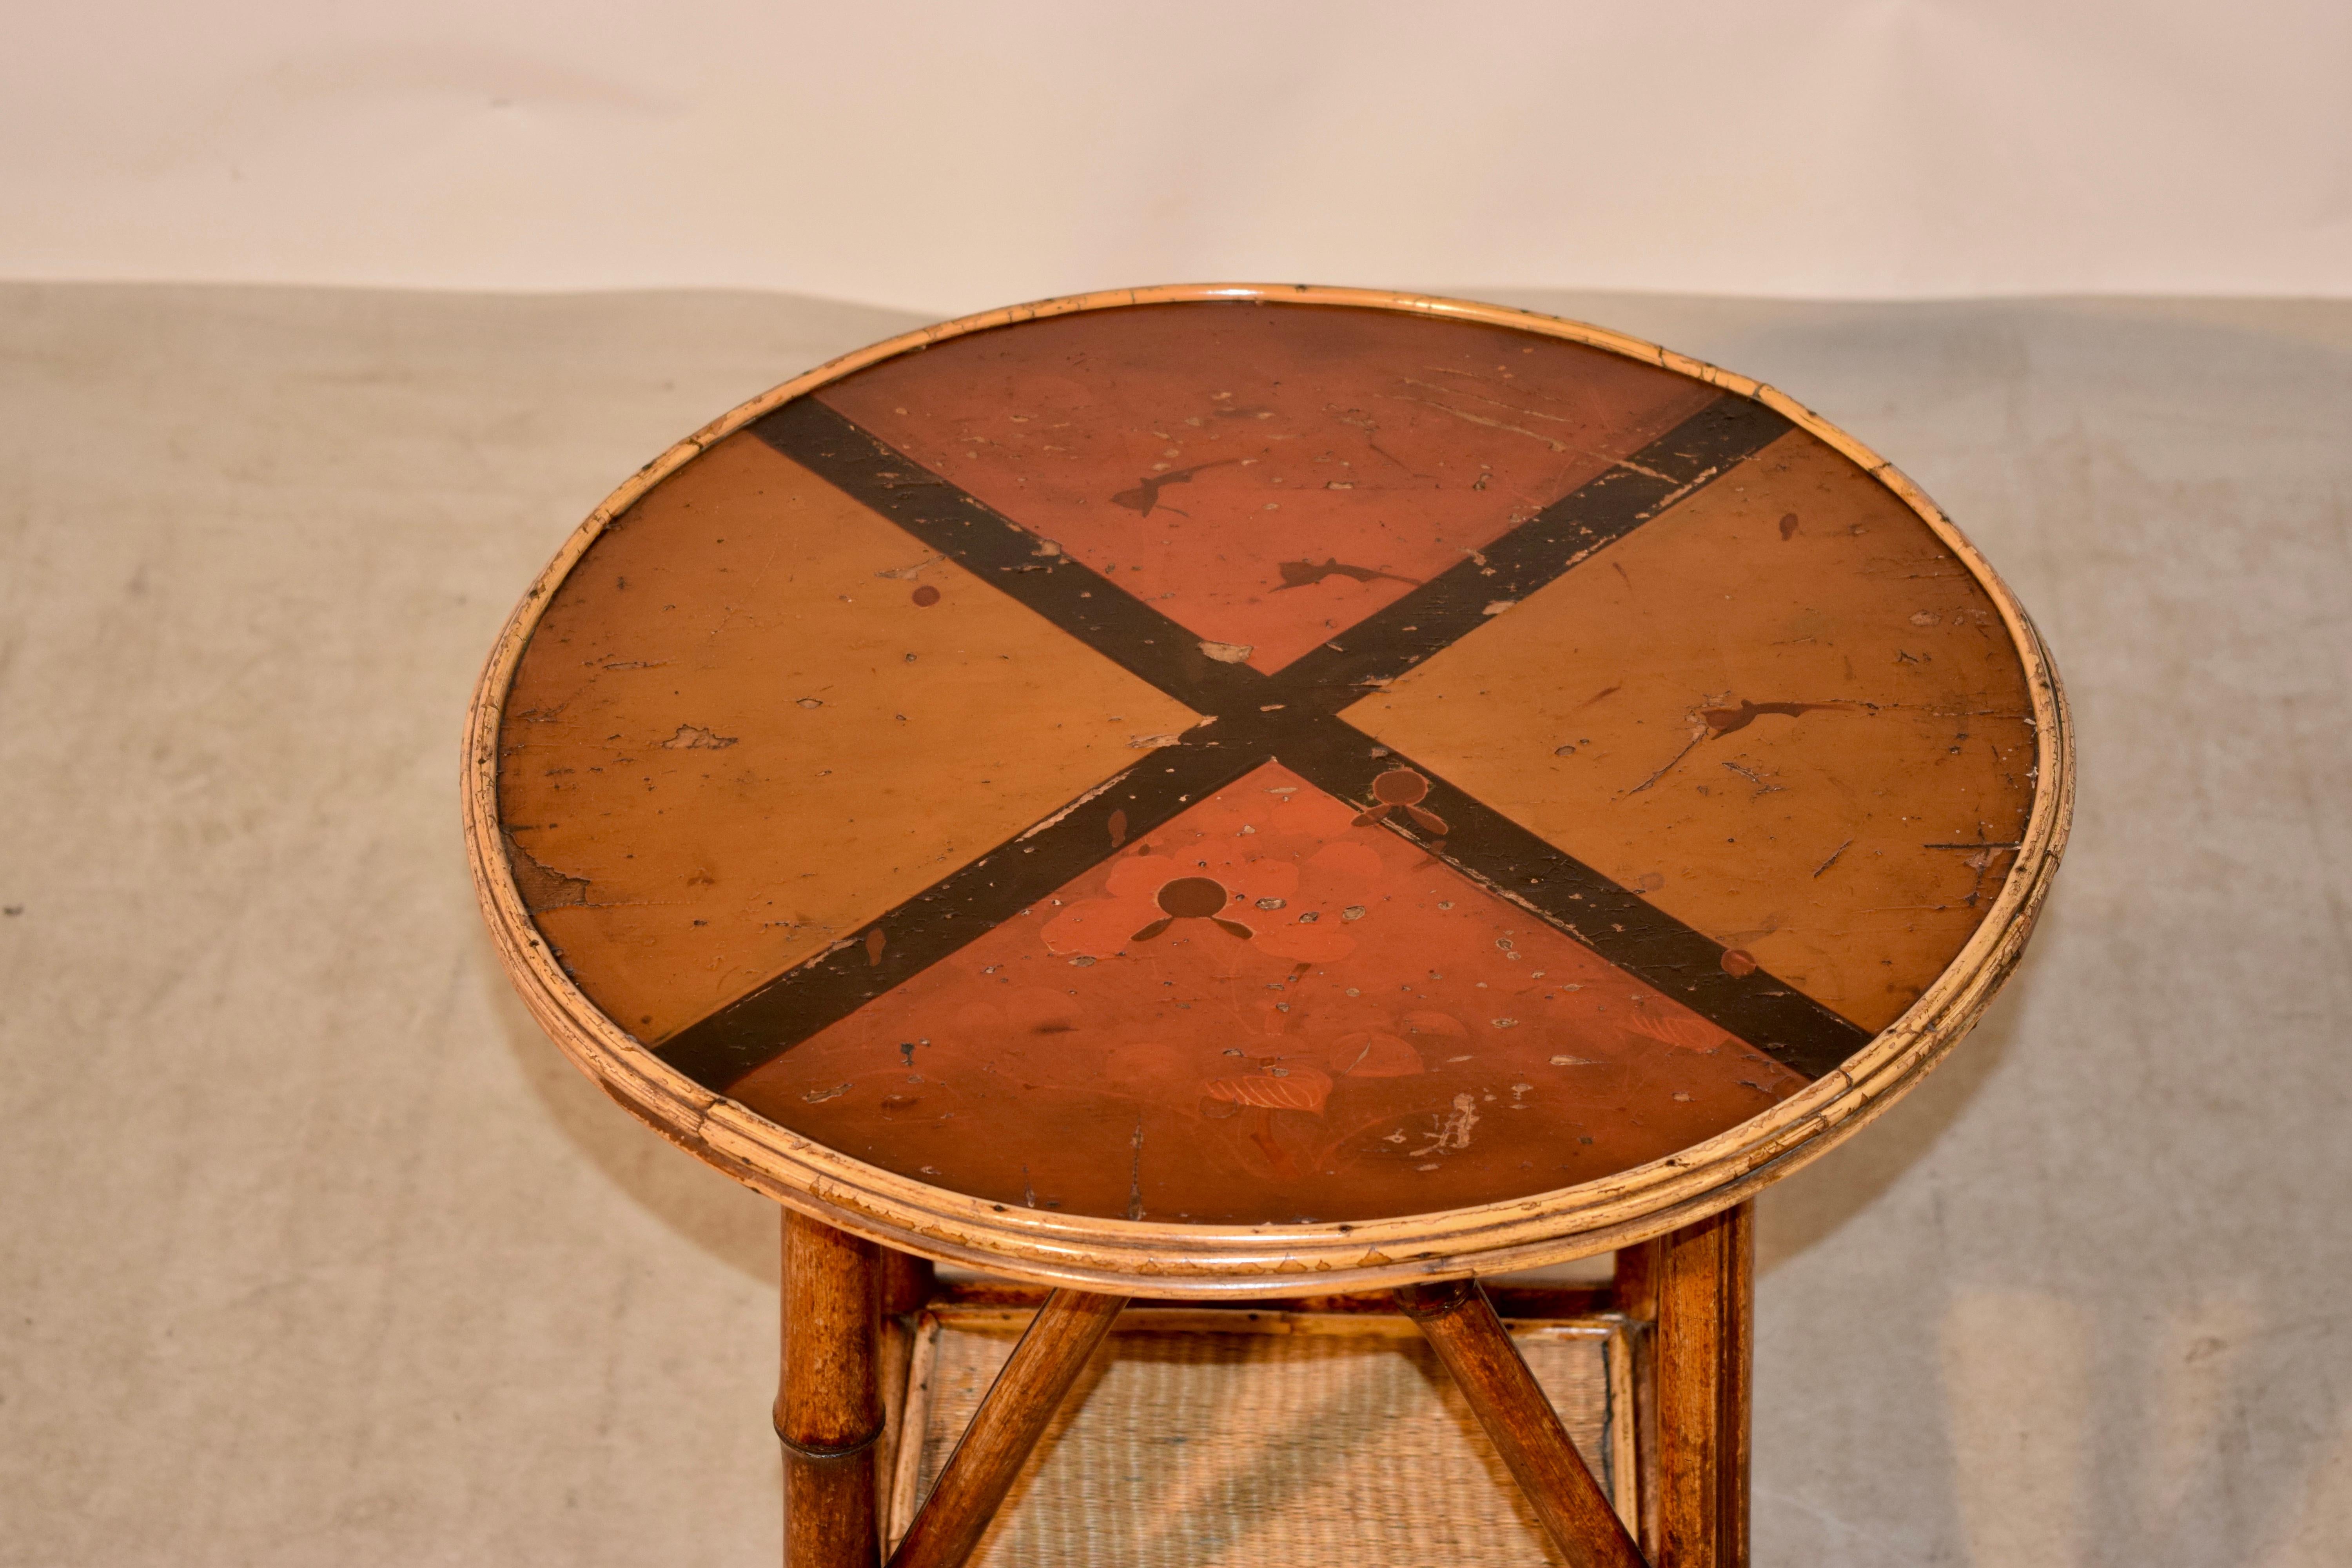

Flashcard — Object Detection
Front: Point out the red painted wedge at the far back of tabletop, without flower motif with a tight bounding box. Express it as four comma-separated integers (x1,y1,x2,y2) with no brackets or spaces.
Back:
816,303,1715,672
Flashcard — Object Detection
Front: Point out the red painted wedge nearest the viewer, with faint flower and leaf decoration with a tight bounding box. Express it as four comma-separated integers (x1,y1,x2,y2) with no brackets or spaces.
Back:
731,764,1802,1225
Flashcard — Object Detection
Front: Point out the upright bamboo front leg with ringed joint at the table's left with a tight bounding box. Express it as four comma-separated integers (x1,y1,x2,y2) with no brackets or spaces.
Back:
776,1210,882,1568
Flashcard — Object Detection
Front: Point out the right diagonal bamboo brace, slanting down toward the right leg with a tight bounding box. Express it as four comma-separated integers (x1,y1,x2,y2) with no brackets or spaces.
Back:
1397,1279,1644,1568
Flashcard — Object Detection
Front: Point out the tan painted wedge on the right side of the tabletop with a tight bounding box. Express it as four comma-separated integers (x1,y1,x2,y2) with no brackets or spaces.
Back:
1343,430,2034,1030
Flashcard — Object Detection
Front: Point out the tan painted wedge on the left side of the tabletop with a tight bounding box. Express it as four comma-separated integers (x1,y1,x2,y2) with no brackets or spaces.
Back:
499,435,1195,1042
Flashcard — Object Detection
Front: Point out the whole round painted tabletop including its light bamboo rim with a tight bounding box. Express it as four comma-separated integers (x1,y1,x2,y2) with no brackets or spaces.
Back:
468,287,2070,1295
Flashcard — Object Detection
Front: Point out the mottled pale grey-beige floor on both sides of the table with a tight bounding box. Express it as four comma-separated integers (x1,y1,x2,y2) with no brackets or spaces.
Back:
0,287,2352,1568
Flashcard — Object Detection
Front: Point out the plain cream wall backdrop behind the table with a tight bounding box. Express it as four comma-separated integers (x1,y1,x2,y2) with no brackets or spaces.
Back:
0,0,2352,310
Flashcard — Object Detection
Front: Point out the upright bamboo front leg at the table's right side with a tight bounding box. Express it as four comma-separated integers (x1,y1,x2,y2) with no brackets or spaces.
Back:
1658,1203,1755,1568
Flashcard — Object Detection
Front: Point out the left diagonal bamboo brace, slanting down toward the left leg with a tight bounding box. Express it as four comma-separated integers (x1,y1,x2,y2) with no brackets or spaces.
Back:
889,1290,1127,1568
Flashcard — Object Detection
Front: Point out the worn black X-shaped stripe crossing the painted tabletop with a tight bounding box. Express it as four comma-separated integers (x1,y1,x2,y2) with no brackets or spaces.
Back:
659,395,1870,1089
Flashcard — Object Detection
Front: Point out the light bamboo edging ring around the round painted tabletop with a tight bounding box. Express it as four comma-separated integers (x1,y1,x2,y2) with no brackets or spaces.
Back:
461,285,2074,1300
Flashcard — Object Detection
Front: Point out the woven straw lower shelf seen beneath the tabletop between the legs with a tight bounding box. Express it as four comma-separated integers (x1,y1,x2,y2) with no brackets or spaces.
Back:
887,1302,1635,1568
